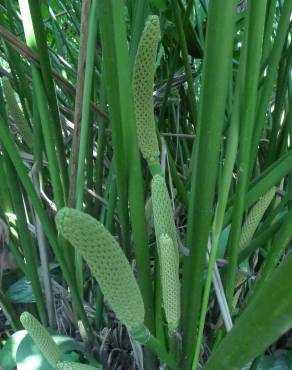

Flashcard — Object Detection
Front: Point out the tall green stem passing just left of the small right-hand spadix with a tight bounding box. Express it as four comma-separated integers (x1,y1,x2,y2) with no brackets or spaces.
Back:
226,1,266,309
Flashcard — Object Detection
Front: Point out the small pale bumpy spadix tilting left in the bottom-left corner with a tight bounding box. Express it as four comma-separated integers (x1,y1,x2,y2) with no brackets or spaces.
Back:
20,312,62,368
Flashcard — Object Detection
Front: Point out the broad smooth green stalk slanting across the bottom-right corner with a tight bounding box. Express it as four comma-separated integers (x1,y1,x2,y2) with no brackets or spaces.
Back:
205,256,292,370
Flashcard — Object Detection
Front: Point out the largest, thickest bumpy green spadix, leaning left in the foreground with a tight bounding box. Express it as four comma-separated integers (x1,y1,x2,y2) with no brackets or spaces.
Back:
56,208,144,331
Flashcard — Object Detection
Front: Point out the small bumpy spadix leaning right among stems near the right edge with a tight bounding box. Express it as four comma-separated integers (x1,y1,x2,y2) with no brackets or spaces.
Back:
240,187,276,250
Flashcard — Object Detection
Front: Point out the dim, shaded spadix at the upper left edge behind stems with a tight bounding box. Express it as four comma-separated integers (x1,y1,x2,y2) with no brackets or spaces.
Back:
2,78,32,148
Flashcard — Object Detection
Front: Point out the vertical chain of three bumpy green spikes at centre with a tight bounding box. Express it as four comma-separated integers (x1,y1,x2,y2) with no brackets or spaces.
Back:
133,16,180,333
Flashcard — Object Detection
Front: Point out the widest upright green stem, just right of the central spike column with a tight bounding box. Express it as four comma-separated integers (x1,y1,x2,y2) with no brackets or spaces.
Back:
181,0,236,370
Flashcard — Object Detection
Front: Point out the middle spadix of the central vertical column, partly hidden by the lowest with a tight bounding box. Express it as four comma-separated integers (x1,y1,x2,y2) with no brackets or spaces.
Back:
151,175,179,260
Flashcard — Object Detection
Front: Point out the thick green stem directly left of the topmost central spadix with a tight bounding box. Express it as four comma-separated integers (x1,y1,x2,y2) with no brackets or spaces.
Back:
99,0,154,350
